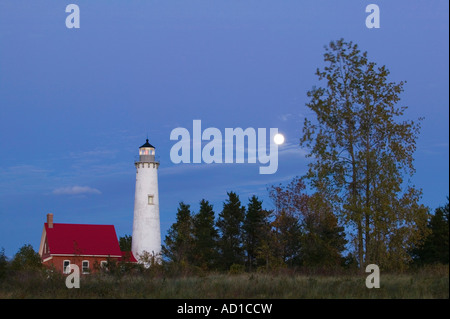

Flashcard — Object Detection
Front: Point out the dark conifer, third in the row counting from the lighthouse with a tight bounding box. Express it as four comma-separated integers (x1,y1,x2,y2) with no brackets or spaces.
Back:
217,192,245,269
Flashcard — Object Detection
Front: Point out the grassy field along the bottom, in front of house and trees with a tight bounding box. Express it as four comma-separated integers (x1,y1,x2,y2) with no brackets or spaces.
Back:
0,266,449,299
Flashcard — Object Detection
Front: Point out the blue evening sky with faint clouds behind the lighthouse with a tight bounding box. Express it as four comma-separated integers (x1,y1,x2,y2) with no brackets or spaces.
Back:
0,0,449,256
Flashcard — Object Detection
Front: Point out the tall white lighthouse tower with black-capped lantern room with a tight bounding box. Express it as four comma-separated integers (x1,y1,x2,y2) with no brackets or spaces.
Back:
131,139,161,260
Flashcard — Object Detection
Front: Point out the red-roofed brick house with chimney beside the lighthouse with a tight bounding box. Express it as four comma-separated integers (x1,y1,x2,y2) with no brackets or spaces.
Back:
39,214,136,274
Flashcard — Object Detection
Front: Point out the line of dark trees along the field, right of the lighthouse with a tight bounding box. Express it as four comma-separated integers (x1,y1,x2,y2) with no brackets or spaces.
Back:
155,178,448,272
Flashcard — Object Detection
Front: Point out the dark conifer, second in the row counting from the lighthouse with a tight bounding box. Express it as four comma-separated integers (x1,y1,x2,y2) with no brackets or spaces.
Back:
193,199,218,269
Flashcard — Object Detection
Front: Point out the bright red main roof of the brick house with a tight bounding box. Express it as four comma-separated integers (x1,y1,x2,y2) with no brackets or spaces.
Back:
45,223,122,257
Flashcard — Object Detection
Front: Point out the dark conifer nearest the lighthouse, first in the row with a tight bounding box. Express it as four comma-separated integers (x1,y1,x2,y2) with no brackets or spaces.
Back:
162,202,193,266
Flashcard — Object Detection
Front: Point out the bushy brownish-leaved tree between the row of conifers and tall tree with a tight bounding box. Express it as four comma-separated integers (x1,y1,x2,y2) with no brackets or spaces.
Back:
269,177,347,266
